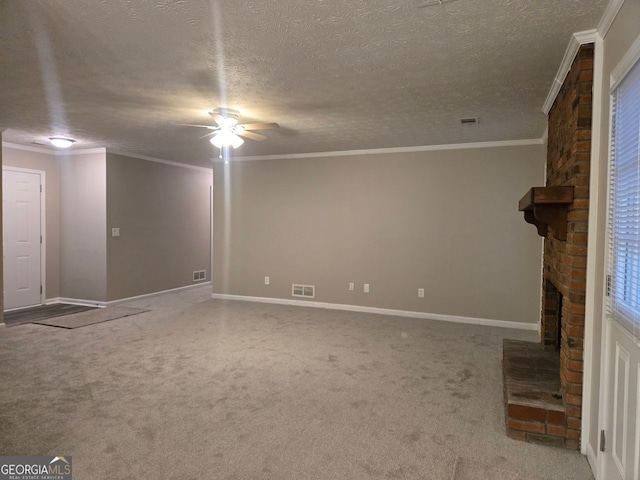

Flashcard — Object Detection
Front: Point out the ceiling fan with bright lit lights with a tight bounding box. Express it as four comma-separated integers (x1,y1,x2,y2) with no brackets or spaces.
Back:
183,108,280,148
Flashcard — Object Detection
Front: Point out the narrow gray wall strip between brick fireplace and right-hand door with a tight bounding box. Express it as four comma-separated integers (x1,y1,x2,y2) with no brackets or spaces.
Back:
585,0,640,460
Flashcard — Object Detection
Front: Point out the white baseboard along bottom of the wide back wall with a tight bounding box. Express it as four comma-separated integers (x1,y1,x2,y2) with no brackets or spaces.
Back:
211,293,539,332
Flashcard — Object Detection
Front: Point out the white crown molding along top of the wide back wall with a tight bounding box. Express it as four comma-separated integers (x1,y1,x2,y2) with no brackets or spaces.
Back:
222,138,543,163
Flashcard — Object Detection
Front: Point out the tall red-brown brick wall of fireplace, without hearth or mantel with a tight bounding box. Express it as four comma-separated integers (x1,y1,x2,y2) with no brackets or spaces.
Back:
541,44,593,448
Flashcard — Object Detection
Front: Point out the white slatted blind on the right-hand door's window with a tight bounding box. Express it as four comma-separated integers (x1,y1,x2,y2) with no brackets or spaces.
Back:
609,57,640,341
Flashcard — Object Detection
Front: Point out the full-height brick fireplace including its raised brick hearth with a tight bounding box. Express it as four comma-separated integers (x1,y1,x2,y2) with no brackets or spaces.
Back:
504,44,594,449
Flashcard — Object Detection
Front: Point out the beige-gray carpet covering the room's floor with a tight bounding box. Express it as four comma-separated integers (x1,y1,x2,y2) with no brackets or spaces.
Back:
0,288,593,480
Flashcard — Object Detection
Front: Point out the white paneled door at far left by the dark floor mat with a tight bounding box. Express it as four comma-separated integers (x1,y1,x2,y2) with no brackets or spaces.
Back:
2,169,42,310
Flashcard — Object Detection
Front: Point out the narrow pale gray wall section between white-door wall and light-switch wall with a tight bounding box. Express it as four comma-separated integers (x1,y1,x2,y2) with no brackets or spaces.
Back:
58,150,107,301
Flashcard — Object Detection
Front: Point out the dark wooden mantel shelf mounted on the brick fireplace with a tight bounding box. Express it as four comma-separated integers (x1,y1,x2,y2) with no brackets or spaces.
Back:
518,187,573,241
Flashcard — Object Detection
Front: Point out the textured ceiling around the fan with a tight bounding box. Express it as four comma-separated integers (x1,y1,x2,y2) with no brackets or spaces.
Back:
0,0,607,165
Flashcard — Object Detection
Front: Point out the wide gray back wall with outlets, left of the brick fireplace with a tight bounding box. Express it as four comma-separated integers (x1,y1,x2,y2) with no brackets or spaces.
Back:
213,145,545,323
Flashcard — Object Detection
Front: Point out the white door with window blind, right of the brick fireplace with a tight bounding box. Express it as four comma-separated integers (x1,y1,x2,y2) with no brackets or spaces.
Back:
600,54,640,480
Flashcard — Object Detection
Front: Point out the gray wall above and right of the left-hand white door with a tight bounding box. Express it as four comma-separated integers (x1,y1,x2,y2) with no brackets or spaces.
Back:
2,146,60,298
